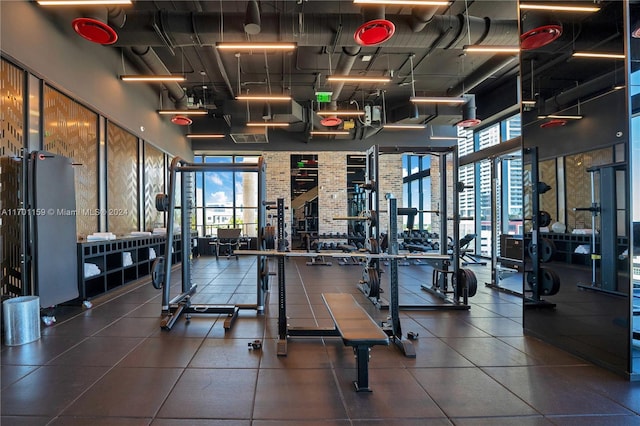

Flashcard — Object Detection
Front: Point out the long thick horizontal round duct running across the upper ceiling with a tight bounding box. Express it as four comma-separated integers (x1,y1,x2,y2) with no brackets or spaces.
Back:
113,11,518,49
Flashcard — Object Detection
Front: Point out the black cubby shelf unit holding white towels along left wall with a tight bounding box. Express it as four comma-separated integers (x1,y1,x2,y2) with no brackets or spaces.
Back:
78,235,182,300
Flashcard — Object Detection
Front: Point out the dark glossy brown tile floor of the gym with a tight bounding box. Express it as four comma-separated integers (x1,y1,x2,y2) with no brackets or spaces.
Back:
1,257,640,426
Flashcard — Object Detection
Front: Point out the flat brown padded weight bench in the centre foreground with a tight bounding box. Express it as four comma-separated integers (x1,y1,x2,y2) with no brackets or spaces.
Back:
322,293,389,392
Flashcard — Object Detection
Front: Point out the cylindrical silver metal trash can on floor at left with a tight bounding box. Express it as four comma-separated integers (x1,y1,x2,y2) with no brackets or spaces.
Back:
2,296,40,346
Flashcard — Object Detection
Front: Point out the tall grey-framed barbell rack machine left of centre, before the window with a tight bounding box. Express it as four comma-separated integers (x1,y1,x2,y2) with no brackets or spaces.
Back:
151,157,268,330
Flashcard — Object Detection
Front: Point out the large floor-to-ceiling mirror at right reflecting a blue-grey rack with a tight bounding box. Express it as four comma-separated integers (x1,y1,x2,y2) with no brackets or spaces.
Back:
520,1,635,375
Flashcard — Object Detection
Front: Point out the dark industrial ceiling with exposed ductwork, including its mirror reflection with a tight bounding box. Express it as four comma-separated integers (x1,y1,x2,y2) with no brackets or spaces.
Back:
36,0,621,146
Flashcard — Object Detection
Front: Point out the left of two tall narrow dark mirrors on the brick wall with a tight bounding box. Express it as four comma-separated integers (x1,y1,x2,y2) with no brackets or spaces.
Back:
290,154,318,249
